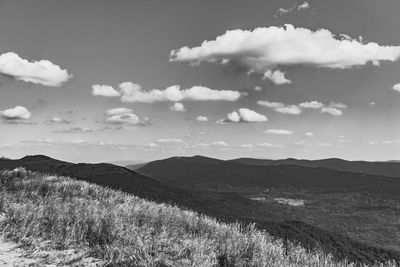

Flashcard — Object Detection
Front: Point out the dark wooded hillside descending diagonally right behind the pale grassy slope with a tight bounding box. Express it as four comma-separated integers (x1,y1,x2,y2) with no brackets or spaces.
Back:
0,155,400,264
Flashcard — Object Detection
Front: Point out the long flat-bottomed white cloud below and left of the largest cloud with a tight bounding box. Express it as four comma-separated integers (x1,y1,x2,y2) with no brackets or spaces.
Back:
119,82,240,103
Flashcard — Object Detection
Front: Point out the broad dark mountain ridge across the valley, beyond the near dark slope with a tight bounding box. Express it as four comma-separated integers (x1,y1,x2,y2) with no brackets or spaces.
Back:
137,156,400,194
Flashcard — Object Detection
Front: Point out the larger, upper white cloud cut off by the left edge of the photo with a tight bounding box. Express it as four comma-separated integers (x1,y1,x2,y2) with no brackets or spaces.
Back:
0,52,72,87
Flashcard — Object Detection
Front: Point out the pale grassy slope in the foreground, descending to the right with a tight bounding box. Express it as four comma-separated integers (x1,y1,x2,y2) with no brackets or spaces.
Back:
0,169,395,266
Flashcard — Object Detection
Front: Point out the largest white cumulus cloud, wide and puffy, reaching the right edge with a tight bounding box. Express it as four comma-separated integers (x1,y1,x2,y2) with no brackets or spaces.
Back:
170,25,400,82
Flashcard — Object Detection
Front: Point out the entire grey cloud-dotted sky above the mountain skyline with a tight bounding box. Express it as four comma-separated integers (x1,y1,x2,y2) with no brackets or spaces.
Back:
0,0,400,162
